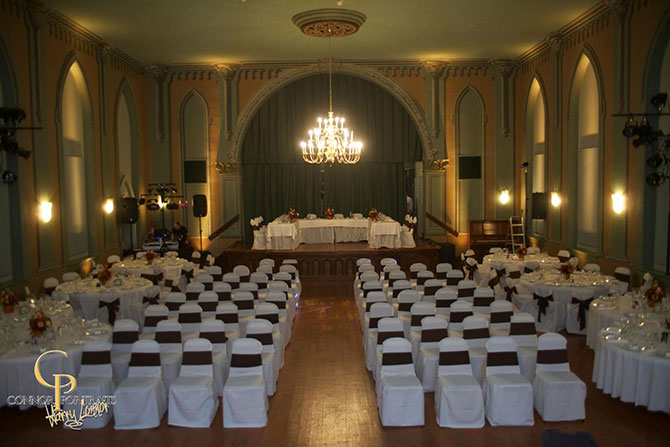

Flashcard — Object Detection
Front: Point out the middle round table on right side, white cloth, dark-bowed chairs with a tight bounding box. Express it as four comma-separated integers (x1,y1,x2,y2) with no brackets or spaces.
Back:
516,270,616,330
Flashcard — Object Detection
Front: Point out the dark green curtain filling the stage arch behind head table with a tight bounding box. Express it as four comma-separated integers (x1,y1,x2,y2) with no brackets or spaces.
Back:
242,75,422,239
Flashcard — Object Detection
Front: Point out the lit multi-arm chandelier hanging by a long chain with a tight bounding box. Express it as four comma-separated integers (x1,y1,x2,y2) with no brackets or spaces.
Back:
300,37,363,164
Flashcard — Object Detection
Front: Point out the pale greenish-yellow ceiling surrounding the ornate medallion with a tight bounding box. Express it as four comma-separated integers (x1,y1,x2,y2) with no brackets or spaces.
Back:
50,0,598,64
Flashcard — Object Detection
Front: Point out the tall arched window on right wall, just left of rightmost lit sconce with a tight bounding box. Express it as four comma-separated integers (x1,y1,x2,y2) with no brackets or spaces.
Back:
570,54,602,252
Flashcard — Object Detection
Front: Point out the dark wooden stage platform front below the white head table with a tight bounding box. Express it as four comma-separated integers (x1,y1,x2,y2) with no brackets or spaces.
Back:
217,240,439,280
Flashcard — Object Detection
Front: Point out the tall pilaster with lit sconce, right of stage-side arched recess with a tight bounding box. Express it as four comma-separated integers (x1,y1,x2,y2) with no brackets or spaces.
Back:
490,59,516,219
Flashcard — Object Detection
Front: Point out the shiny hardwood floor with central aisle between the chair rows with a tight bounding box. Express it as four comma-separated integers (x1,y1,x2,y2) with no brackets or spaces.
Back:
0,281,670,447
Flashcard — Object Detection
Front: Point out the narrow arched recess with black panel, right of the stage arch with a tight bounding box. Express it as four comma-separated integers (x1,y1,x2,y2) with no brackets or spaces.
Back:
455,87,484,233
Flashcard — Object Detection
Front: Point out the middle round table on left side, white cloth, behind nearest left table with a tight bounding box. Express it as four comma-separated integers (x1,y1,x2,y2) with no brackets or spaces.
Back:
56,276,154,325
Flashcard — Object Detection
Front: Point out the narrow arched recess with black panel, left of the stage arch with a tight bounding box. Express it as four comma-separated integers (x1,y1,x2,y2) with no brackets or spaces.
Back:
181,91,210,245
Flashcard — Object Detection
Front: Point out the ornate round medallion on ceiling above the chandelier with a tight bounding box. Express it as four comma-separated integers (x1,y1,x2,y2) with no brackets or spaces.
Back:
293,8,367,37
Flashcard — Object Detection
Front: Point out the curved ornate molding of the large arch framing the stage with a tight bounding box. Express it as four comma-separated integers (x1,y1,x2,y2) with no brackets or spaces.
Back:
227,60,436,163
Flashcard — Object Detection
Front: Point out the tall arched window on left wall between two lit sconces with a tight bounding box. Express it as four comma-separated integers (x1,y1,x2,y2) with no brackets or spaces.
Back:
60,62,95,261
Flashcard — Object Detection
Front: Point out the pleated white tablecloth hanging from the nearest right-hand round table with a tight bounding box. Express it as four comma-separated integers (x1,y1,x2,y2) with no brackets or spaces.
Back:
592,330,670,413
